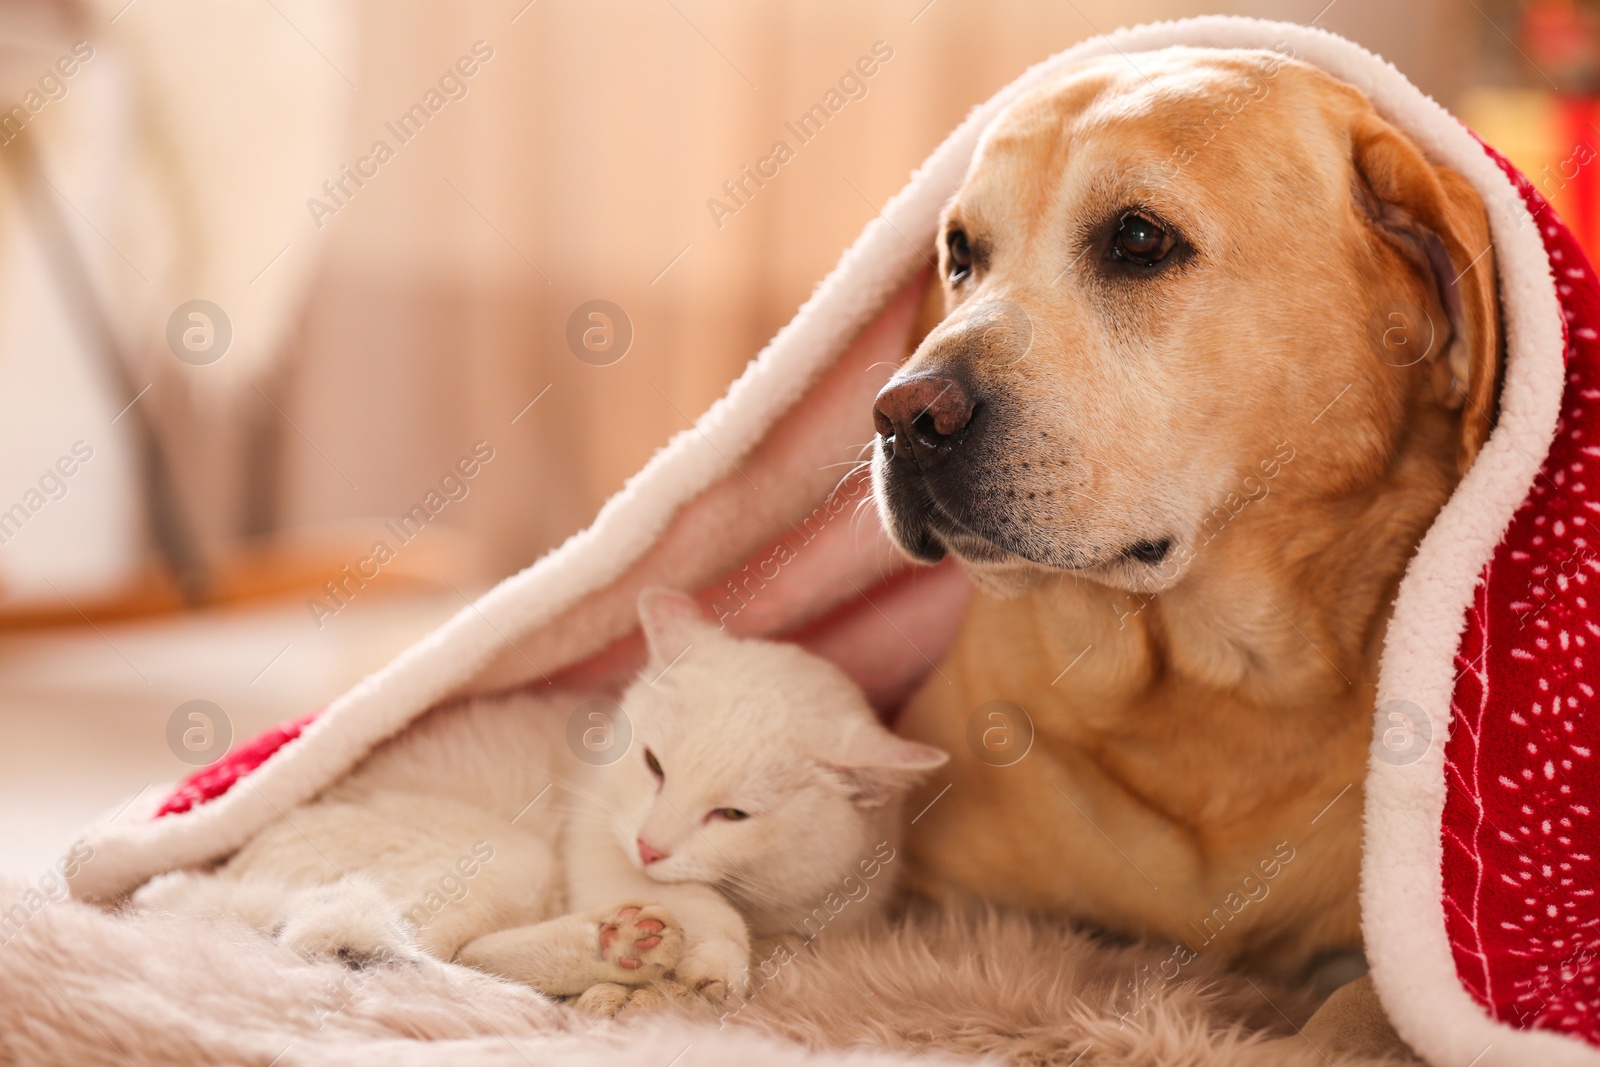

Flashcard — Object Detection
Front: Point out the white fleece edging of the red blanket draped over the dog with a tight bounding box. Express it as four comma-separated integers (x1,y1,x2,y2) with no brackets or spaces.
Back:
74,16,1574,1067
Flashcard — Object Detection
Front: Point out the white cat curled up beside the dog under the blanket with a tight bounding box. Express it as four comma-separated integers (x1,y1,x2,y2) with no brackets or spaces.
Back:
134,590,947,1013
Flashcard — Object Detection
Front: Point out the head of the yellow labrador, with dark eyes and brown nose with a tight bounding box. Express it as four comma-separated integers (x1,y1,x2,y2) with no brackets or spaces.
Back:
874,50,1499,590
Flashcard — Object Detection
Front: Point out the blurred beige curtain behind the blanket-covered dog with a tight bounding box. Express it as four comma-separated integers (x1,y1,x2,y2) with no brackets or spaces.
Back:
209,0,1467,576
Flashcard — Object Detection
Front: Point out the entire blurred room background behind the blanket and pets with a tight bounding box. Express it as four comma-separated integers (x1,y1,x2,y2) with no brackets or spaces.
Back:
0,0,1600,875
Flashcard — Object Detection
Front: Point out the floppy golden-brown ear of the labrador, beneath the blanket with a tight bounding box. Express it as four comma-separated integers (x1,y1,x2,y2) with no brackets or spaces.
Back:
1352,112,1501,474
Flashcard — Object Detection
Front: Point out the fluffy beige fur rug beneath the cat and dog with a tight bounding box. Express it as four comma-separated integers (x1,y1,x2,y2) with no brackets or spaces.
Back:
0,881,1420,1067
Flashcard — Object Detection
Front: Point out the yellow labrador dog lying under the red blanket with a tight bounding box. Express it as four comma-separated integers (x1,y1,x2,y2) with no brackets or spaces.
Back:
874,50,1501,977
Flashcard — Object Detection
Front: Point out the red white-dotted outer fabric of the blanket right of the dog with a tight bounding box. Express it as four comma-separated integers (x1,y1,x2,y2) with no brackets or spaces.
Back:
1442,141,1600,1043
